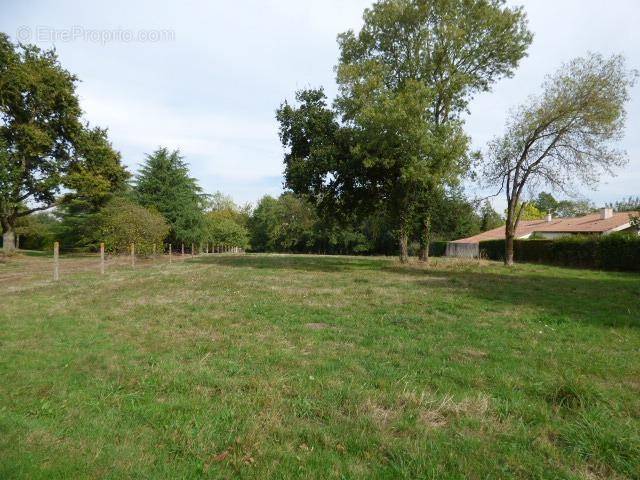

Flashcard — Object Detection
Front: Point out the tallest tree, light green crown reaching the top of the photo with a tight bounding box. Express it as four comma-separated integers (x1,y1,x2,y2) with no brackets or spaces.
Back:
337,0,532,261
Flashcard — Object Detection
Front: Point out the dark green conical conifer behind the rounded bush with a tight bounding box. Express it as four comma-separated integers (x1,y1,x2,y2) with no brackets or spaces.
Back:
134,148,206,243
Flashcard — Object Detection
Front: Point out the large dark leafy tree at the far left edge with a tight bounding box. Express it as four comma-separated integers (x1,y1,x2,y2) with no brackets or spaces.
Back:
0,33,83,251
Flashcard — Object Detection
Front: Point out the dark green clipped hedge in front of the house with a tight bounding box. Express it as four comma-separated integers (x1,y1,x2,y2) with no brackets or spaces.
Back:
480,233,640,272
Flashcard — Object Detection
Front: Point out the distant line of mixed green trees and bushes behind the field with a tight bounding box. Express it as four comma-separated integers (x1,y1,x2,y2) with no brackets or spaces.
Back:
11,158,502,255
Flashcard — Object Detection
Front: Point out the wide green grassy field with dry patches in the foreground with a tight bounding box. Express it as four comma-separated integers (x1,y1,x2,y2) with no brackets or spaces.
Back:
0,255,640,479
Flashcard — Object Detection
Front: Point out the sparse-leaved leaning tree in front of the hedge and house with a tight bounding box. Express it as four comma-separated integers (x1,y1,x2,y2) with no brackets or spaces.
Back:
484,54,636,265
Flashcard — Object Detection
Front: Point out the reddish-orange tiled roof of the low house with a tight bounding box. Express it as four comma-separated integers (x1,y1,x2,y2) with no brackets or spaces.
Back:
455,212,638,243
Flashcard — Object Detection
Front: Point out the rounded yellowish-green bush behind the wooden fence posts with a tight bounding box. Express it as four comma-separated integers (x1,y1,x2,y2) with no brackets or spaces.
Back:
96,198,169,254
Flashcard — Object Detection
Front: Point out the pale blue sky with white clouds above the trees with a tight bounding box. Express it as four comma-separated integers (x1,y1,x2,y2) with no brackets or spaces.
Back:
0,0,640,208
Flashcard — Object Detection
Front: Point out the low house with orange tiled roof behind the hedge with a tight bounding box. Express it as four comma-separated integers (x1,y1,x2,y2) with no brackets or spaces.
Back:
446,208,639,257
